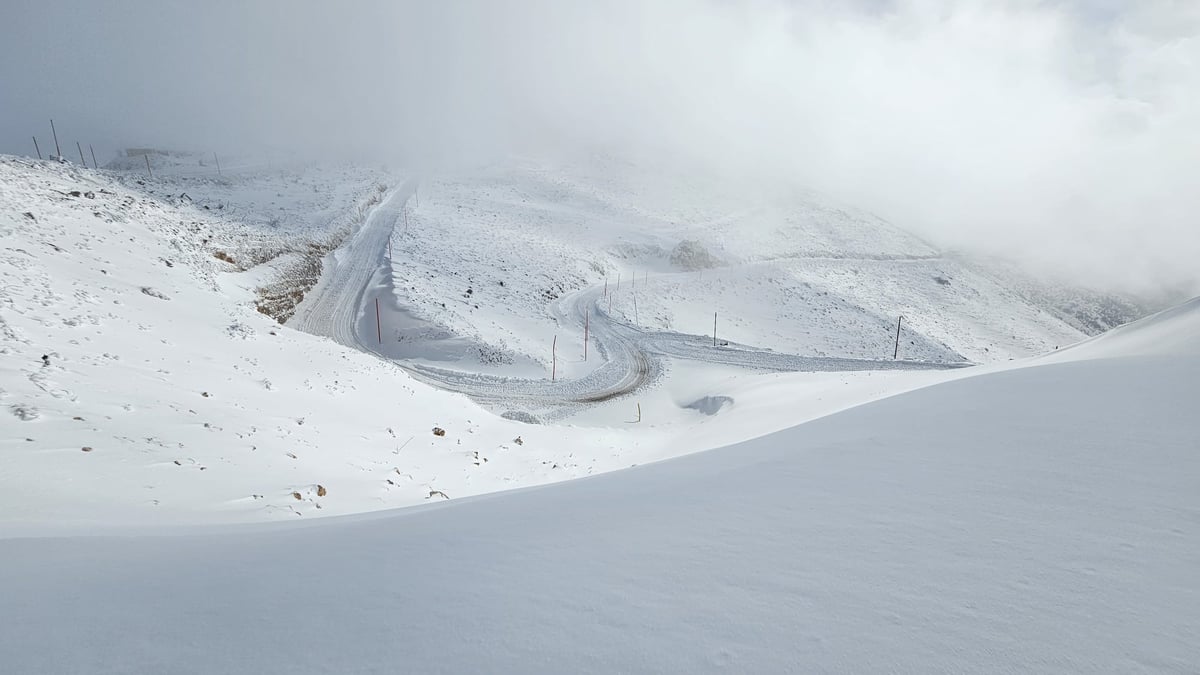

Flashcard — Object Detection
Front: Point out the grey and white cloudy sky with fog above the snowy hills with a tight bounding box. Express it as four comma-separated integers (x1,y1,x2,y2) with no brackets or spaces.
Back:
0,0,1200,292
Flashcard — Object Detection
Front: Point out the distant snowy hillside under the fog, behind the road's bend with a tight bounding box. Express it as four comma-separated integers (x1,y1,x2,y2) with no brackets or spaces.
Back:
392,156,1085,370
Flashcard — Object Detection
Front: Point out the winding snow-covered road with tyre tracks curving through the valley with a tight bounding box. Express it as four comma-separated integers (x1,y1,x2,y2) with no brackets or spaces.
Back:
288,179,966,418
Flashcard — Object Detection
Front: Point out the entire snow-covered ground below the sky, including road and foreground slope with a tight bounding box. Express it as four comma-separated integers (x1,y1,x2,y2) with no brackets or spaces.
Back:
0,156,1200,673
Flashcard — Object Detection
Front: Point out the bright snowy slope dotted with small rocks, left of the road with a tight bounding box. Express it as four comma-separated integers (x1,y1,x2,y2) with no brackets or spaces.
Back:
0,157,661,526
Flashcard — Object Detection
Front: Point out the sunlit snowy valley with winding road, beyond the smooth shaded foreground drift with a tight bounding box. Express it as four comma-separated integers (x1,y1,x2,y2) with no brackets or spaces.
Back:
0,155,1132,526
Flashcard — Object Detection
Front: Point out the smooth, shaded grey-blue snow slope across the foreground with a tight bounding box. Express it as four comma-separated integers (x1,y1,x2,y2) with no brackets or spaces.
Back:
0,291,1200,674
